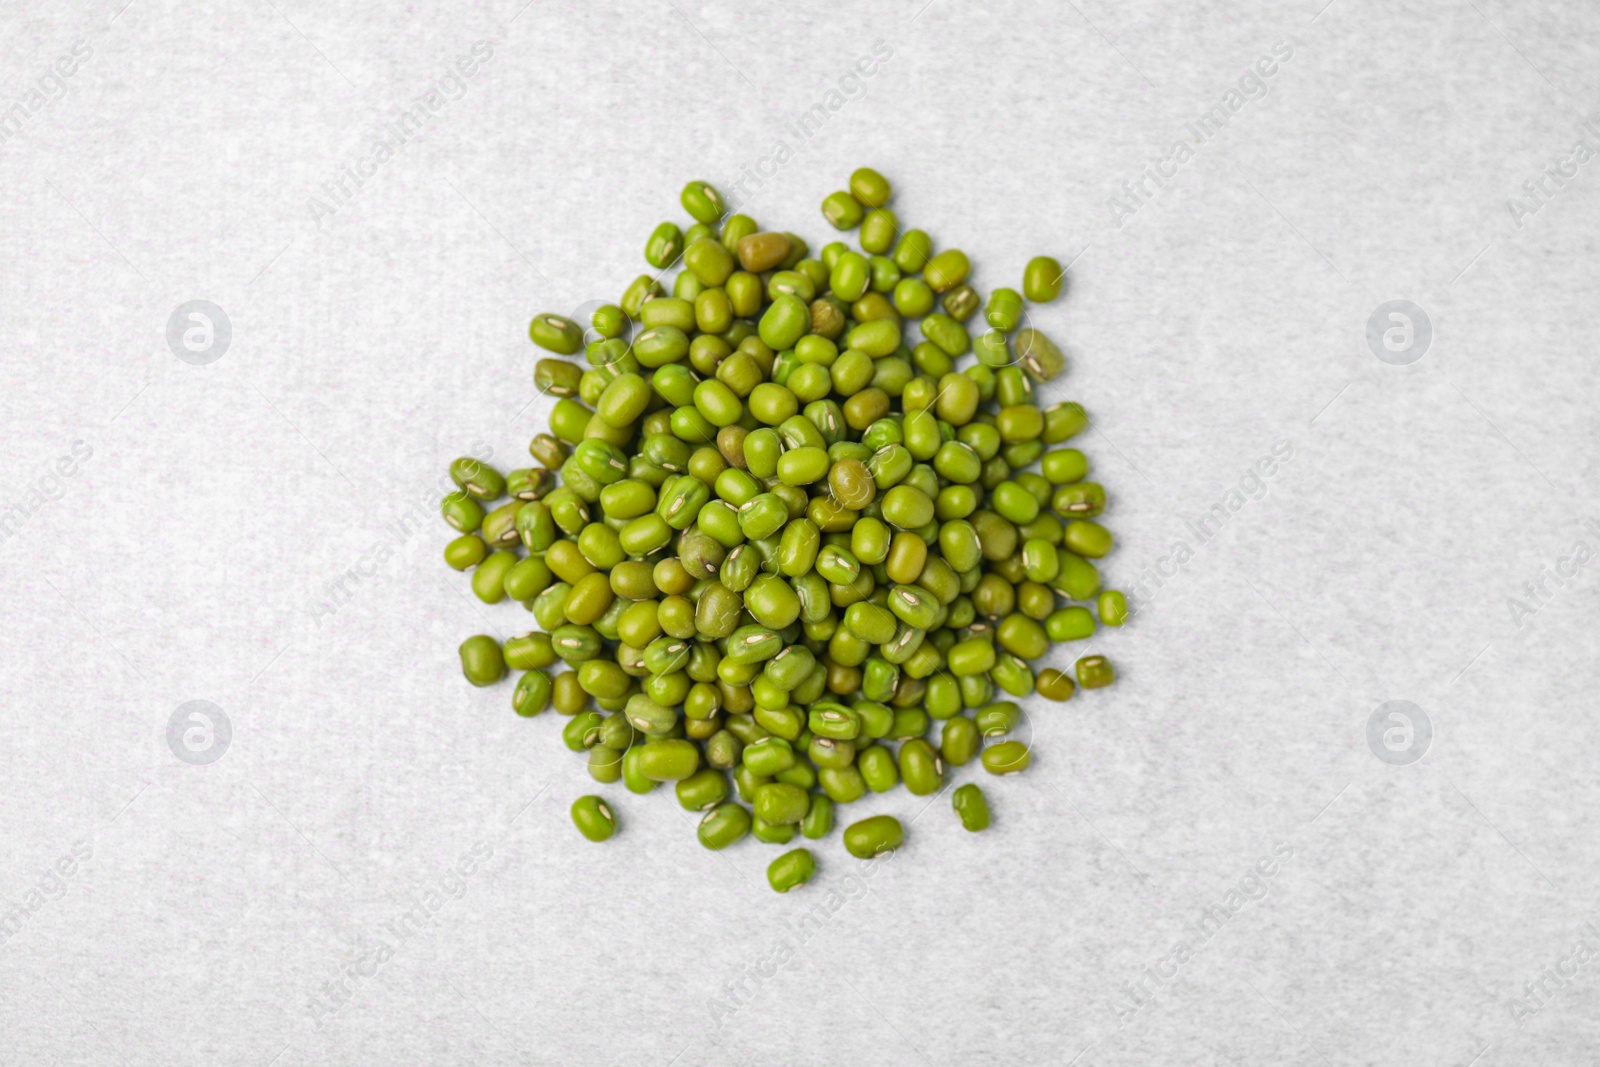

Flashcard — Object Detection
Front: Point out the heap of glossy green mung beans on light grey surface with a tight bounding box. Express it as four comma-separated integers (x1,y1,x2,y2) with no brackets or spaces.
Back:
442,168,1128,893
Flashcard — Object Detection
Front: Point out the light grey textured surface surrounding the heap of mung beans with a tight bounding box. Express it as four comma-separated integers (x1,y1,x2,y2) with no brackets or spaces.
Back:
0,0,1600,1067
